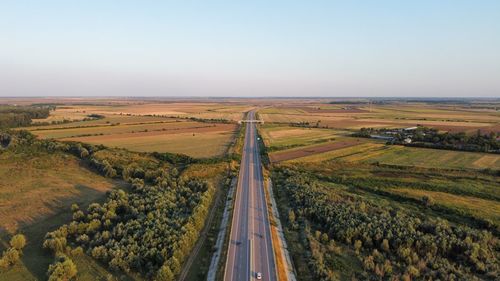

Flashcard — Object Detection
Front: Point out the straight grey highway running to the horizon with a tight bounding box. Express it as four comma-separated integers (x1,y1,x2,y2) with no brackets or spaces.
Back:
224,111,276,281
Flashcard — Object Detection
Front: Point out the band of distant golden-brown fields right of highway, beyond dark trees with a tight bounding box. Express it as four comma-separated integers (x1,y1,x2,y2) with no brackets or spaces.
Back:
259,103,500,133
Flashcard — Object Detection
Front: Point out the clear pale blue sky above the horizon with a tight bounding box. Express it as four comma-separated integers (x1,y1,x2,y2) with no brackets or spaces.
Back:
0,0,500,97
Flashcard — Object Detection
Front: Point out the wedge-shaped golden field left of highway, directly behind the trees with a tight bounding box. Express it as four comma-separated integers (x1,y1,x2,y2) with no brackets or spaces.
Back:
62,123,237,158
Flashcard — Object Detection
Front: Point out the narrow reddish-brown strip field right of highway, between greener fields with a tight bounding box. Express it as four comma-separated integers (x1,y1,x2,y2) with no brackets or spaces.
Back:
269,138,365,163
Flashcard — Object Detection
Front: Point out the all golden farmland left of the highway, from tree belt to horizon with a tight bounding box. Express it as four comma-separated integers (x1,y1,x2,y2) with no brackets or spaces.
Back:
23,103,244,158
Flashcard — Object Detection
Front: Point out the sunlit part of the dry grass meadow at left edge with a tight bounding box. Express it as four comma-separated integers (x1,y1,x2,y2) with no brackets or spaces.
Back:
0,152,115,233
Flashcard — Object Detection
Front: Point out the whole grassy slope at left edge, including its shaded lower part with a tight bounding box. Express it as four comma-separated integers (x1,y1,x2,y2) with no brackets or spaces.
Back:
0,151,125,280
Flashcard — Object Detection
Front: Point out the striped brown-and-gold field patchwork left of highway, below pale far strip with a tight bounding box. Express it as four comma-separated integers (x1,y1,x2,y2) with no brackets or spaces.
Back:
23,115,237,158
